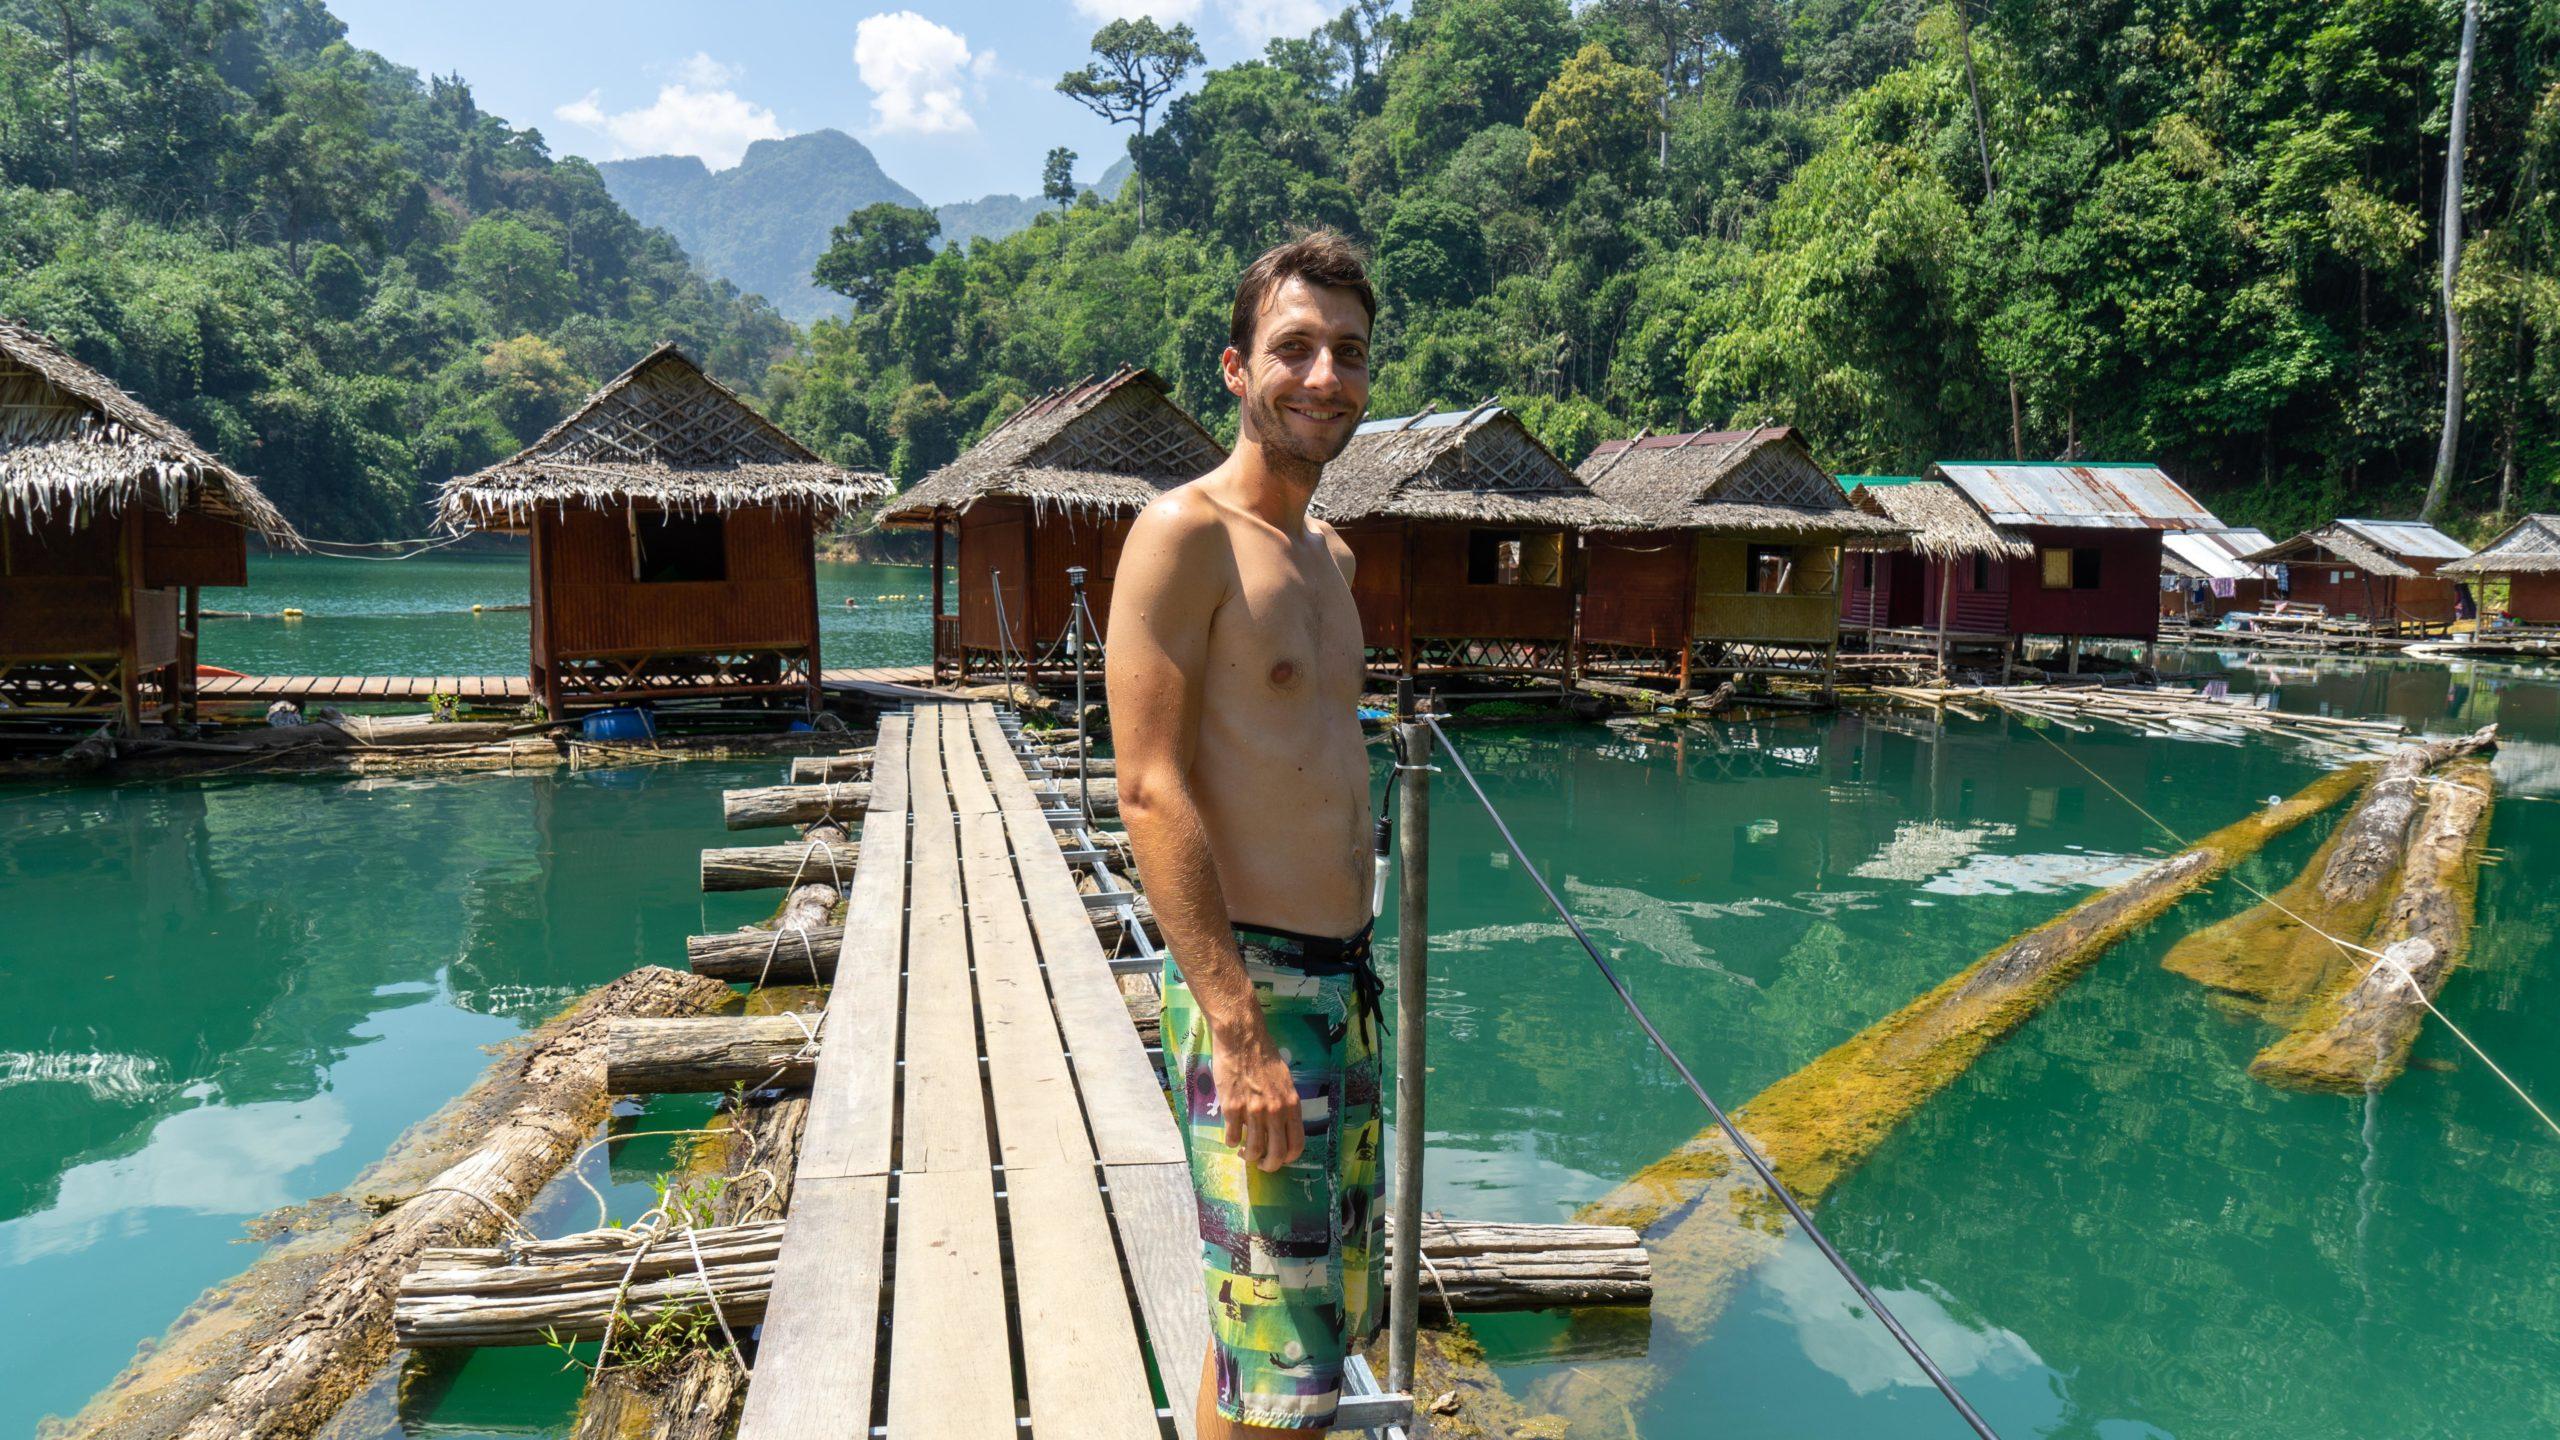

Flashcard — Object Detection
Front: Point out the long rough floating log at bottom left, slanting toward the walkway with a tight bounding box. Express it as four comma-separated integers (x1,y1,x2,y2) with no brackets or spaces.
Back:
59,966,730,1440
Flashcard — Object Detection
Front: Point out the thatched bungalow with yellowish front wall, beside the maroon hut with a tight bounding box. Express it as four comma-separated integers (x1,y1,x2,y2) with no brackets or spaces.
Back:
1580,425,1902,689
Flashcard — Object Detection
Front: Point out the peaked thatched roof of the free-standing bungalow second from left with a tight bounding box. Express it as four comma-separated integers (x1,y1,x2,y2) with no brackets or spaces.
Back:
435,346,891,530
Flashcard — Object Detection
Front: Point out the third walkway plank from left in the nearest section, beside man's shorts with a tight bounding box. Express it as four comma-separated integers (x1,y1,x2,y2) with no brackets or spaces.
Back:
998,1158,1167,1440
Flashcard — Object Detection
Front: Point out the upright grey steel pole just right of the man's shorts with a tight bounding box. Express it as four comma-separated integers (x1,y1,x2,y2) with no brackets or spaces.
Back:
1388,689,1431,1394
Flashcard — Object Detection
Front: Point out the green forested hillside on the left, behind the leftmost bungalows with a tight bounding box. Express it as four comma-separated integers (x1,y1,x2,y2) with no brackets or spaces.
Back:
0,0,794,538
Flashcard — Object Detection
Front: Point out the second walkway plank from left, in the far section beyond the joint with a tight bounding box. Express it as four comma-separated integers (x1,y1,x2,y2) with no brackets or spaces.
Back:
899,707,991,1173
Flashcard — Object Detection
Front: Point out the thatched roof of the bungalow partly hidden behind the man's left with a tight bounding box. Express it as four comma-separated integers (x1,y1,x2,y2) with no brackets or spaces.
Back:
878,364,1226,525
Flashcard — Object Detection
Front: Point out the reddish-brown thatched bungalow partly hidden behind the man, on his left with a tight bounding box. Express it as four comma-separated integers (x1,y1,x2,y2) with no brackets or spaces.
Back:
876,364,1226,674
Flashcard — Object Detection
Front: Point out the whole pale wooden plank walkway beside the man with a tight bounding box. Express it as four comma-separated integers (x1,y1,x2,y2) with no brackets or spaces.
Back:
740,702,1208,1440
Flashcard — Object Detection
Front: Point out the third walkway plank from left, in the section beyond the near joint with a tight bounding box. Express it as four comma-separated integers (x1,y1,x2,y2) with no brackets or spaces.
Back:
960,815,1101,1168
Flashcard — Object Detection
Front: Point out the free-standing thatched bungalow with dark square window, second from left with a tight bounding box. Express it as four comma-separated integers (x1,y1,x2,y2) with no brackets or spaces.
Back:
438,346,891,715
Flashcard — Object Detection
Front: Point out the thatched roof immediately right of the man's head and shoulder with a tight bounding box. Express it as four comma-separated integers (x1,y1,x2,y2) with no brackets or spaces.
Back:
1311,400,1644,530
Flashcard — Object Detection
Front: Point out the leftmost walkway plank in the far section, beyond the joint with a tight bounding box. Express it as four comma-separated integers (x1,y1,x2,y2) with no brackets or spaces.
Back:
799,715,906,1181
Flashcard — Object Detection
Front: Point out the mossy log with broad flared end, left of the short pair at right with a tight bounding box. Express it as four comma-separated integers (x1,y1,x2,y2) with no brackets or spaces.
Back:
2161,725,2496,1004
